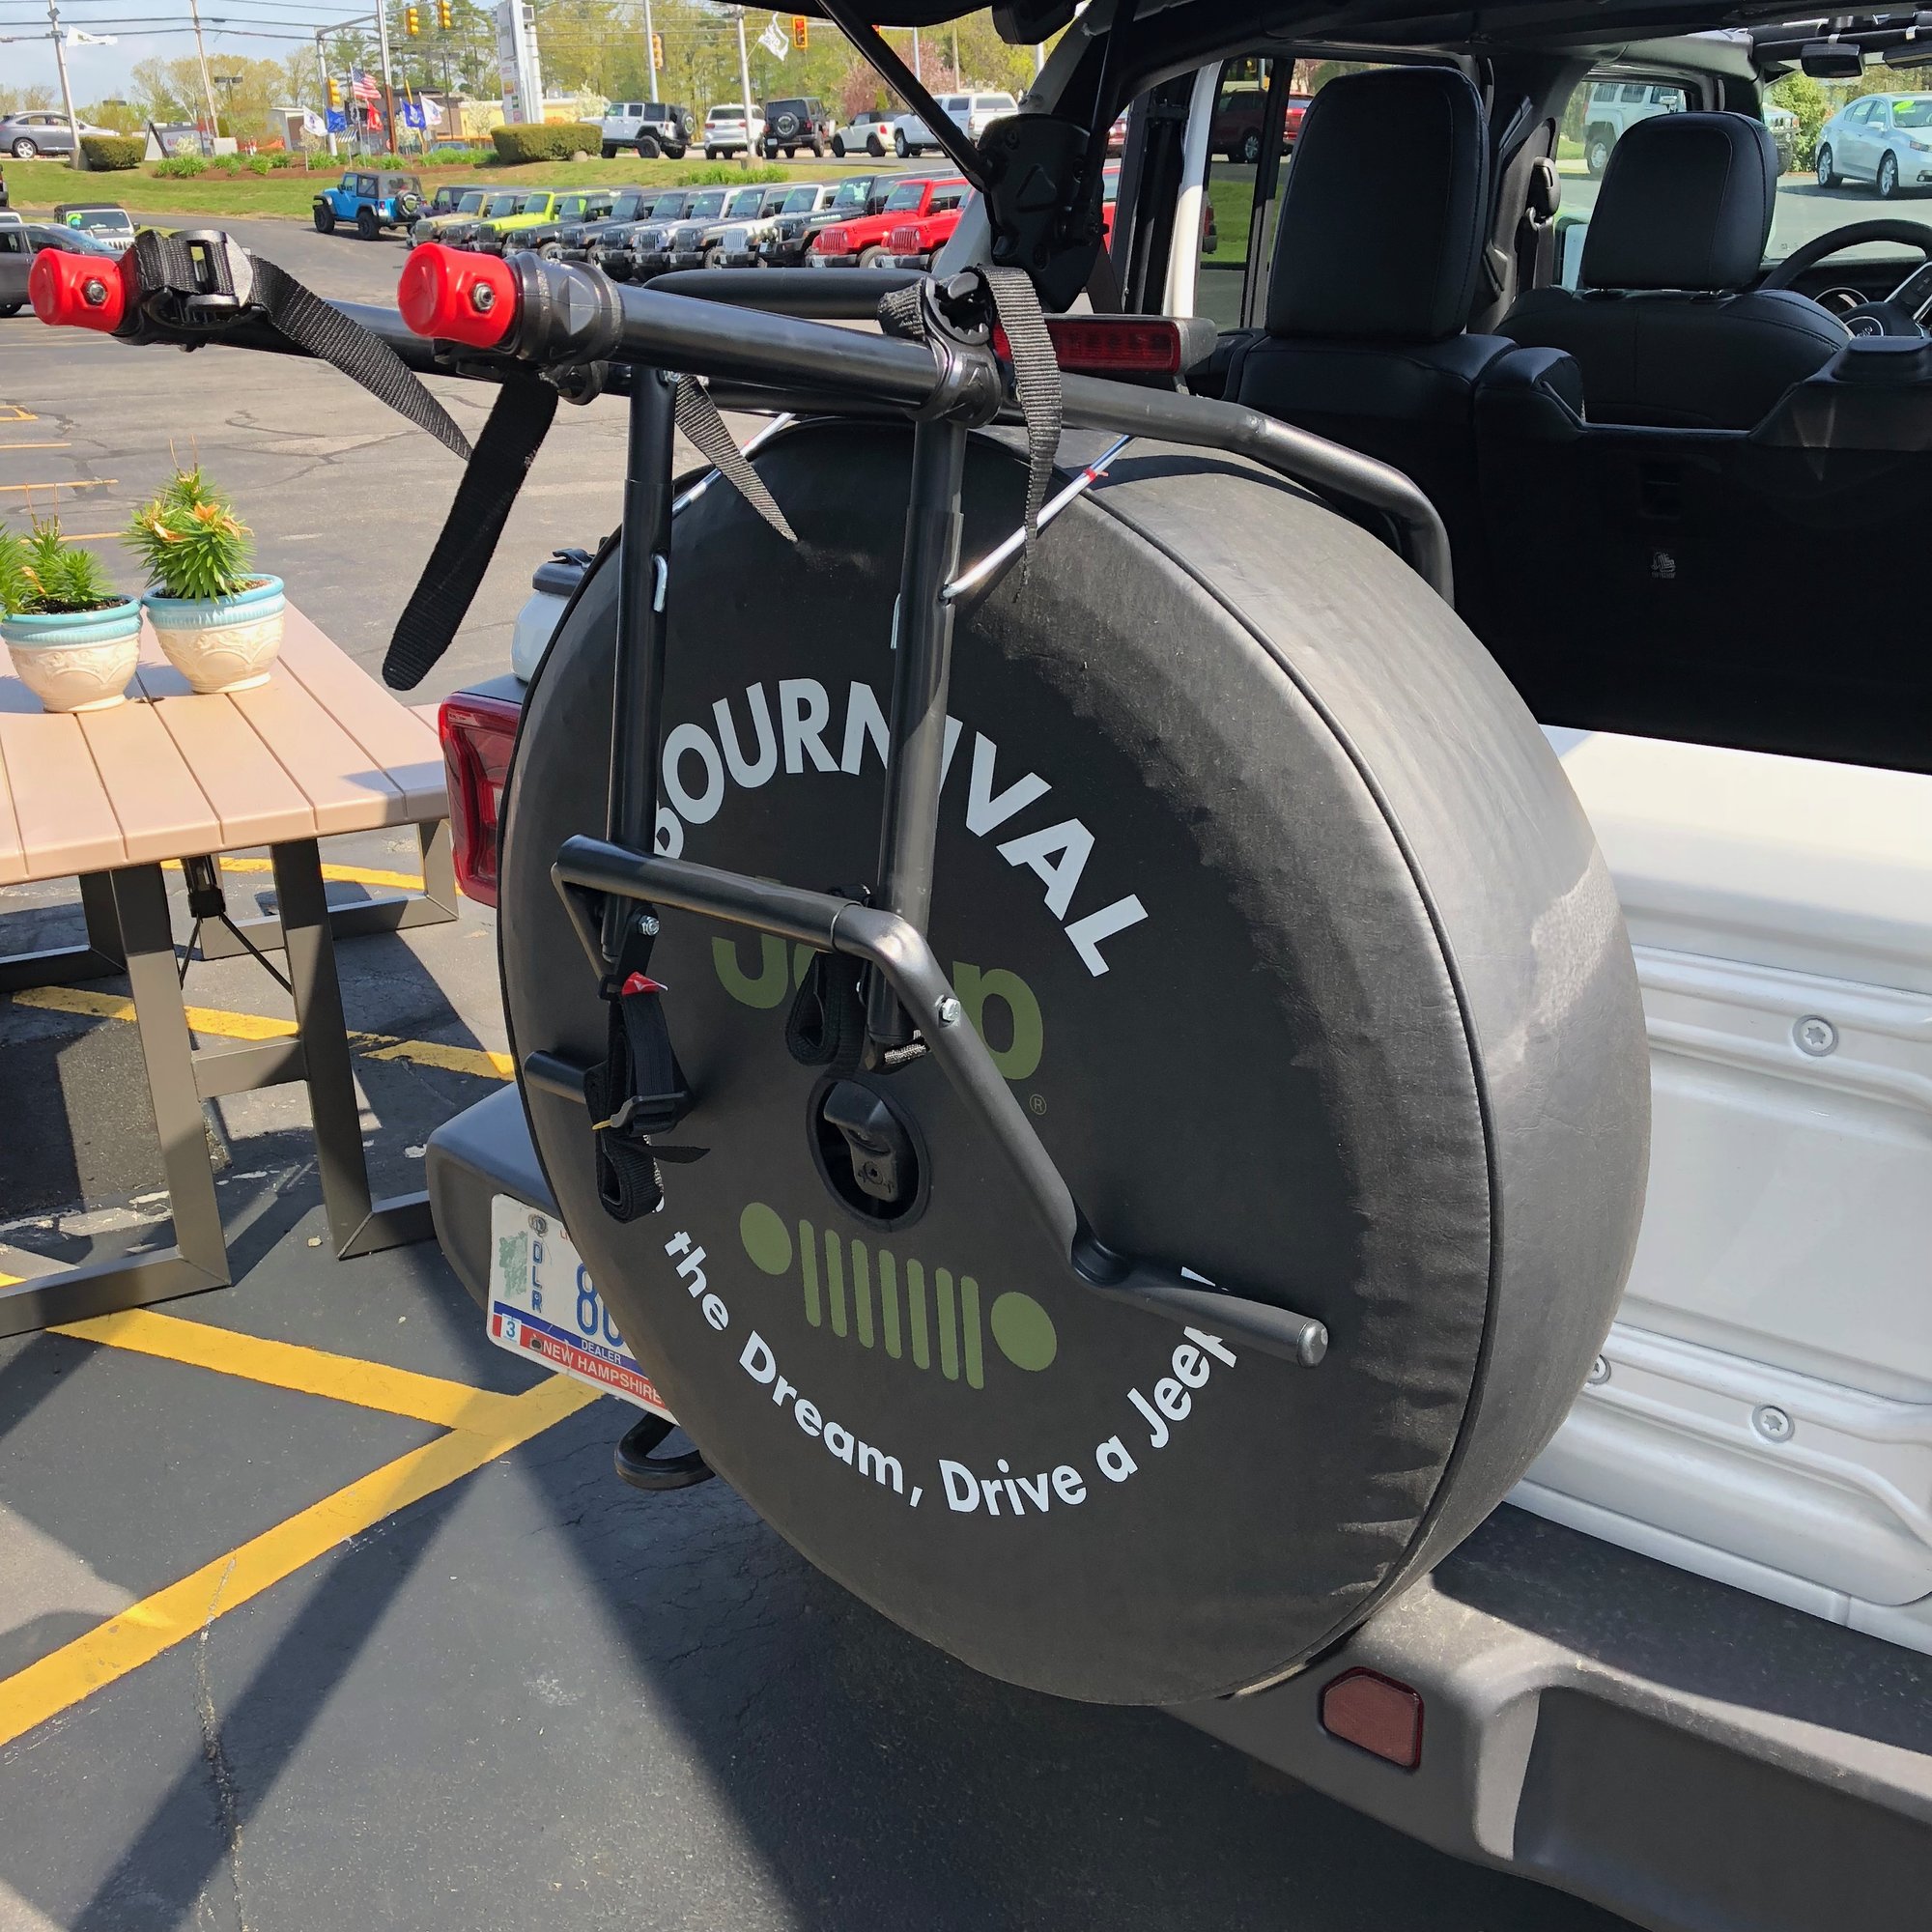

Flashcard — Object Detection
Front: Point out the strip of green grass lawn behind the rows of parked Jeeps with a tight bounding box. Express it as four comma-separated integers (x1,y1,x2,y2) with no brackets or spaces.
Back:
0,155,877,222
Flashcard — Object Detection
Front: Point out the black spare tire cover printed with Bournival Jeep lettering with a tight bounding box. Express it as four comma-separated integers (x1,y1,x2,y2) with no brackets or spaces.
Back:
500,423,1648,1704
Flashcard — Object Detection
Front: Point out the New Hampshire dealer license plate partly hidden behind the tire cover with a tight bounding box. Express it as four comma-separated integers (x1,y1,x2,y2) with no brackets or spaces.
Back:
485,1194,670,1416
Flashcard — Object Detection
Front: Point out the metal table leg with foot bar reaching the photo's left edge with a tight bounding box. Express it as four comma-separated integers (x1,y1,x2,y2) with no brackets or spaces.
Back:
0,866,232,1335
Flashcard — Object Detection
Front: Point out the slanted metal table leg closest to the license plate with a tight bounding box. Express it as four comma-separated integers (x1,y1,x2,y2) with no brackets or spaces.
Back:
269,838,435,1260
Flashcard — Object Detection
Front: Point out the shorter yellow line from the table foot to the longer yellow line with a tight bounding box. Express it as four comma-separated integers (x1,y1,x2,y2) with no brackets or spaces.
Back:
54,1308,537,1434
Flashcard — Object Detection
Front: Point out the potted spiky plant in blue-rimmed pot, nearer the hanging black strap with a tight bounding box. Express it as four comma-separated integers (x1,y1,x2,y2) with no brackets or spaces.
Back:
128,464,282,692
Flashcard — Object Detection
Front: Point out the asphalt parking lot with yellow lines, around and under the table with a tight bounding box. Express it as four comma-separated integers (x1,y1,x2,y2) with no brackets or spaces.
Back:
0,224,1646,1932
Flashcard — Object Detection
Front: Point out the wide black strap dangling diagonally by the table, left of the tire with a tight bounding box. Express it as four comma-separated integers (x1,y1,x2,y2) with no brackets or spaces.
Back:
383,375,558,692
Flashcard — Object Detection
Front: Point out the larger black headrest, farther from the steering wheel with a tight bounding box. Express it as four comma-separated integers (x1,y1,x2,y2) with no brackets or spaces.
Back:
1267,68,1490,342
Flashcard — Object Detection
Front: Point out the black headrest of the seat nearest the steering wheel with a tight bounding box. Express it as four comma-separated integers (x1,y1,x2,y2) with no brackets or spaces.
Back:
1580,114,1777,290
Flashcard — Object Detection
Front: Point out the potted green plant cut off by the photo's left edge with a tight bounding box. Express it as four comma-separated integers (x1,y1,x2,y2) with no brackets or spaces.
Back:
0,516,141,711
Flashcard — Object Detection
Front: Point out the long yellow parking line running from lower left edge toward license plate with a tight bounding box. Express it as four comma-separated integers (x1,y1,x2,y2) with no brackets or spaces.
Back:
0,1376,597,1745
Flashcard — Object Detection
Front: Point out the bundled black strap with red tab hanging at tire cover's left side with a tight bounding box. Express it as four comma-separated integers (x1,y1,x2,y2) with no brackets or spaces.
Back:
583,920,705,1221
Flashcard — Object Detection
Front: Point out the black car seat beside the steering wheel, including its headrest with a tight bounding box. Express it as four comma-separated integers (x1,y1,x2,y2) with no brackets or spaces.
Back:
1497,114,1849,429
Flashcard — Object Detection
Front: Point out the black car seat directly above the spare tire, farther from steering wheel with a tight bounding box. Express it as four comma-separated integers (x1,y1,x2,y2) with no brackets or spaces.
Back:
1227,68,1515,630
